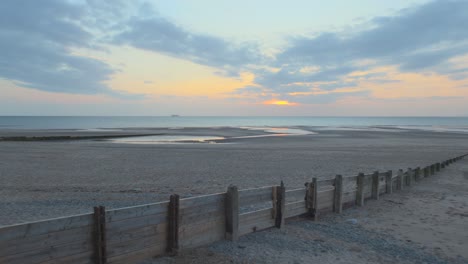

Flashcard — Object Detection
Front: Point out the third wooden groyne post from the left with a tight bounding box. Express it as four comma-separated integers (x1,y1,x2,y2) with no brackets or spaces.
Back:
226,185,239,241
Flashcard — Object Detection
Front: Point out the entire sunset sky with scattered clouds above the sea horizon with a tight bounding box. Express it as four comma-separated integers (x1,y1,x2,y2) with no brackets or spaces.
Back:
0,0,468,116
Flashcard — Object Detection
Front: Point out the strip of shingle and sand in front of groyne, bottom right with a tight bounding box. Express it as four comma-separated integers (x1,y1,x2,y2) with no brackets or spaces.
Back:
154,159,468,264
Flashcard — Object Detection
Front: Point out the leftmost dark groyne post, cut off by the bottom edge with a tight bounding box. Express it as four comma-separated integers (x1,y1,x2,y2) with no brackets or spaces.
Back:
94,206,107,264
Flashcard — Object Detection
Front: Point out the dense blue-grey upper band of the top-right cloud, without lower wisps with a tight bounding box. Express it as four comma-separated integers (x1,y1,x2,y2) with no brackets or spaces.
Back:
278,0,468,70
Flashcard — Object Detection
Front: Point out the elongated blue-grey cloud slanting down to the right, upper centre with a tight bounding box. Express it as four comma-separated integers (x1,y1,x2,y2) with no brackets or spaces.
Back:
113,11,261,75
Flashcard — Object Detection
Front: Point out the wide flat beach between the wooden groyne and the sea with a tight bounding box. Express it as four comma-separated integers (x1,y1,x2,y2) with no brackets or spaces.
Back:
0,127,468,225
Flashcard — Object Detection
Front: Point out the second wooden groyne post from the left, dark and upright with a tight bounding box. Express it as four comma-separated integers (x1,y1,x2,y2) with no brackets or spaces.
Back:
167,194,180,255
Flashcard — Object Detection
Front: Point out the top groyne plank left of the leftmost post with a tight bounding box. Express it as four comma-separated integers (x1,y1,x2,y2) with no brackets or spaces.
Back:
0,214,93,242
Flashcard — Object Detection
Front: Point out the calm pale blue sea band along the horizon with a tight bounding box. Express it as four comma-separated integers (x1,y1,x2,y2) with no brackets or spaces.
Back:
0,116,468,129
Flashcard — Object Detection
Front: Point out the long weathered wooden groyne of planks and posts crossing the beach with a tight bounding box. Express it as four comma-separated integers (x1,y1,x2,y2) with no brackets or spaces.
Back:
0,155,467,264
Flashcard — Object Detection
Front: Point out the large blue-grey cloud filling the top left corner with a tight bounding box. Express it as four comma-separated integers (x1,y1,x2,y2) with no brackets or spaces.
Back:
0,0,115,94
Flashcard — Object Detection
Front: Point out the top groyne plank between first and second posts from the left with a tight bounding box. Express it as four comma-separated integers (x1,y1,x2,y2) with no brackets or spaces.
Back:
106,201,169,223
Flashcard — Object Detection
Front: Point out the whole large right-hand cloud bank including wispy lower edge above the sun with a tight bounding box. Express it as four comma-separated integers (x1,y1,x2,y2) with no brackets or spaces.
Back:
239,0,468,103
